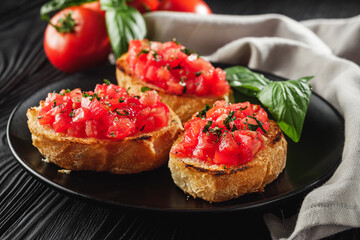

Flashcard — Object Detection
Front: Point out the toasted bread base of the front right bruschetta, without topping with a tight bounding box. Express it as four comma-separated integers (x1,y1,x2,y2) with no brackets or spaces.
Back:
168,120,287,202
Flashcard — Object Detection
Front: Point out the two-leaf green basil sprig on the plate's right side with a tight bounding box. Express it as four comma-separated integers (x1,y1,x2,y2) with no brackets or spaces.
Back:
225,66,313,142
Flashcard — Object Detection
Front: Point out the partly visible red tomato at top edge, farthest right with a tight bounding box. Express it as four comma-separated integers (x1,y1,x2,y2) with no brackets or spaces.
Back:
158,0,212,14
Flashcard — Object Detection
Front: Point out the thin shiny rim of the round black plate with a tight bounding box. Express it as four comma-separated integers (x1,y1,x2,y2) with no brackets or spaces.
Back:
6,69,345,214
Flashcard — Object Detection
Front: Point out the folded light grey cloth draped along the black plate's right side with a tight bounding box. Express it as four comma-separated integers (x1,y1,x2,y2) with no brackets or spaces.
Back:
145,12,360,239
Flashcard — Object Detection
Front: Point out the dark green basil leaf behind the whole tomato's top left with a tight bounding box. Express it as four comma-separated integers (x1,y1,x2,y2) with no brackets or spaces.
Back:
40,0,95,21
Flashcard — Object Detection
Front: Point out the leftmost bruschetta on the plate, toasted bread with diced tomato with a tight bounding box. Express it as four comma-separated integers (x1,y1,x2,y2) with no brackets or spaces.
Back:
27,83,182,174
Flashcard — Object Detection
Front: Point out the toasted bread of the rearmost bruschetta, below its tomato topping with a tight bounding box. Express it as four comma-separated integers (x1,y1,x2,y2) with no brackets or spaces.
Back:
116,53,229,122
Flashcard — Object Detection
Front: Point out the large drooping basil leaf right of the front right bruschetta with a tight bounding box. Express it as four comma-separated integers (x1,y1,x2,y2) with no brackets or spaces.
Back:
257,77,311,142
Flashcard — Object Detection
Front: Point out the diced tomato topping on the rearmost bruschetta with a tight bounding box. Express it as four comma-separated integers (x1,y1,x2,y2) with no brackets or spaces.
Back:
126,40,230,97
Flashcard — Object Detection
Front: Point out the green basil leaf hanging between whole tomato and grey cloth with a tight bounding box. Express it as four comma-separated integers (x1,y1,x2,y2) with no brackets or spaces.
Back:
101,5,146,58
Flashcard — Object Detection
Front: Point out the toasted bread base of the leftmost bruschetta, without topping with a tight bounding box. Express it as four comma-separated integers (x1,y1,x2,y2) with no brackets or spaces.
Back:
26,104,183,174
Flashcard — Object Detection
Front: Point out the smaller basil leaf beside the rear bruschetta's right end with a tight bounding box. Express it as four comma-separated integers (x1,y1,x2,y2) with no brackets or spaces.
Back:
224,66,270,97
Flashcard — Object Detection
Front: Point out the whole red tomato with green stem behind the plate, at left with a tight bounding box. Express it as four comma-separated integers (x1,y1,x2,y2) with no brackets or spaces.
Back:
44,7,110,73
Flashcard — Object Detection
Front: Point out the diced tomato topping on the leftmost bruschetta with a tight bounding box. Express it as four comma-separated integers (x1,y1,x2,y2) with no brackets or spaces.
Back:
39,84,169,140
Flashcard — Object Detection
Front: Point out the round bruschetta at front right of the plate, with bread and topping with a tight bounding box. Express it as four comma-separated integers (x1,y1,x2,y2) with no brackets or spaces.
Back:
168,101,287,202
